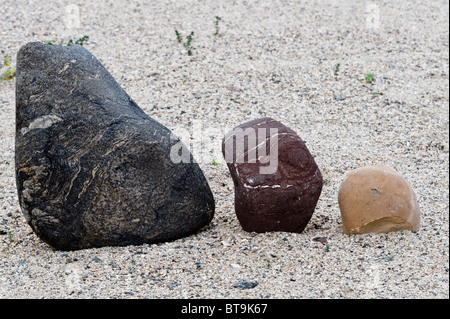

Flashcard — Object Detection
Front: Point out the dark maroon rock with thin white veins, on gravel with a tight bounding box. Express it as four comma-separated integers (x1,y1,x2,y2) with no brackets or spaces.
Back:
222,118,323,232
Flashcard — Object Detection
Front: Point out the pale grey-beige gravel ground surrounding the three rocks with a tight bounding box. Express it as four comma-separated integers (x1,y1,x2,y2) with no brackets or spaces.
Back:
0,0,449,298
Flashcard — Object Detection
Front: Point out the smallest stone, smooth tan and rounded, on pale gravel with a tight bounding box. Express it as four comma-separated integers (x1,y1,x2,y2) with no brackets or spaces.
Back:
338,166,420,234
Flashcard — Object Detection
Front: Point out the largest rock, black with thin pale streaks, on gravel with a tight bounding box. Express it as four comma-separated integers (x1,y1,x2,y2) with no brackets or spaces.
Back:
16,43,215,250
